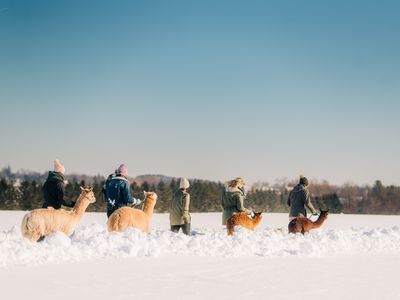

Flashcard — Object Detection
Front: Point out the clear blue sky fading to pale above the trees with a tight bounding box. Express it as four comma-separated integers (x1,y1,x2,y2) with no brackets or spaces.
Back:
0,0,400,184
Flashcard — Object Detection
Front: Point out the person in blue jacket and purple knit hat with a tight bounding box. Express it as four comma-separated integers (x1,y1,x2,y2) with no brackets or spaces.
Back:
103,164,143,218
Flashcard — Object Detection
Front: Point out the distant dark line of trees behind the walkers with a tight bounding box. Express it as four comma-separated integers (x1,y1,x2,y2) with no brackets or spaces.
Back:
0,167,400,214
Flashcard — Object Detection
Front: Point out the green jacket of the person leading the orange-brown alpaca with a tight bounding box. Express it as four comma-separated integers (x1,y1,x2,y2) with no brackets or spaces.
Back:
222,187,251,225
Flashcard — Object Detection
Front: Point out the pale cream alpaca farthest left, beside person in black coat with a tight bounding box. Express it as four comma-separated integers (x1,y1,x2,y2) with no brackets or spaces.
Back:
21,187,96,242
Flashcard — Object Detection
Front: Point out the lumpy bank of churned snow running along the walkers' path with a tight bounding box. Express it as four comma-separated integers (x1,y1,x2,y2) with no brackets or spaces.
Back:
0,223,400,267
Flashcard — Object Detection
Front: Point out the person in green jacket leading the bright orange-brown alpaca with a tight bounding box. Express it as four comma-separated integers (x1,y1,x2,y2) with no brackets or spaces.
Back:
221,177,253,225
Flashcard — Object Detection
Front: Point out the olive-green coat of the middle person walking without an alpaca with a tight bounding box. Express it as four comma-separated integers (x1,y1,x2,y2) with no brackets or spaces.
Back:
169,190,191,226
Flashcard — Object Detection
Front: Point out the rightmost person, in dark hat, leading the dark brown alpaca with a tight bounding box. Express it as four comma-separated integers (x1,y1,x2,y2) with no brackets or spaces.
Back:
287,175,317,221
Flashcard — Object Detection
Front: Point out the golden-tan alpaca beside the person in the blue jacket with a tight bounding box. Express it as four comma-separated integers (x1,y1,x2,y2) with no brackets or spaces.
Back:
107,192,157,232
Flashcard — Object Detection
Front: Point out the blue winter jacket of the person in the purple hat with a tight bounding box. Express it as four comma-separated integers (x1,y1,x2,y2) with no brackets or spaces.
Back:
104,175,138,215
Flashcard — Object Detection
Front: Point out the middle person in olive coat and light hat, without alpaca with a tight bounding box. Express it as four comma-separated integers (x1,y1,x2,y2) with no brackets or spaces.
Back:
169,178,191,235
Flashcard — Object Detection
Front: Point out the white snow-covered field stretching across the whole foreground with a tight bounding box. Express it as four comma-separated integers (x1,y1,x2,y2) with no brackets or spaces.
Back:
0,211,400,299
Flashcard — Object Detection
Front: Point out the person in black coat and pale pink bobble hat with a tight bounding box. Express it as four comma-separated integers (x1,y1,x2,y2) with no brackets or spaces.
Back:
42,159,75,209
